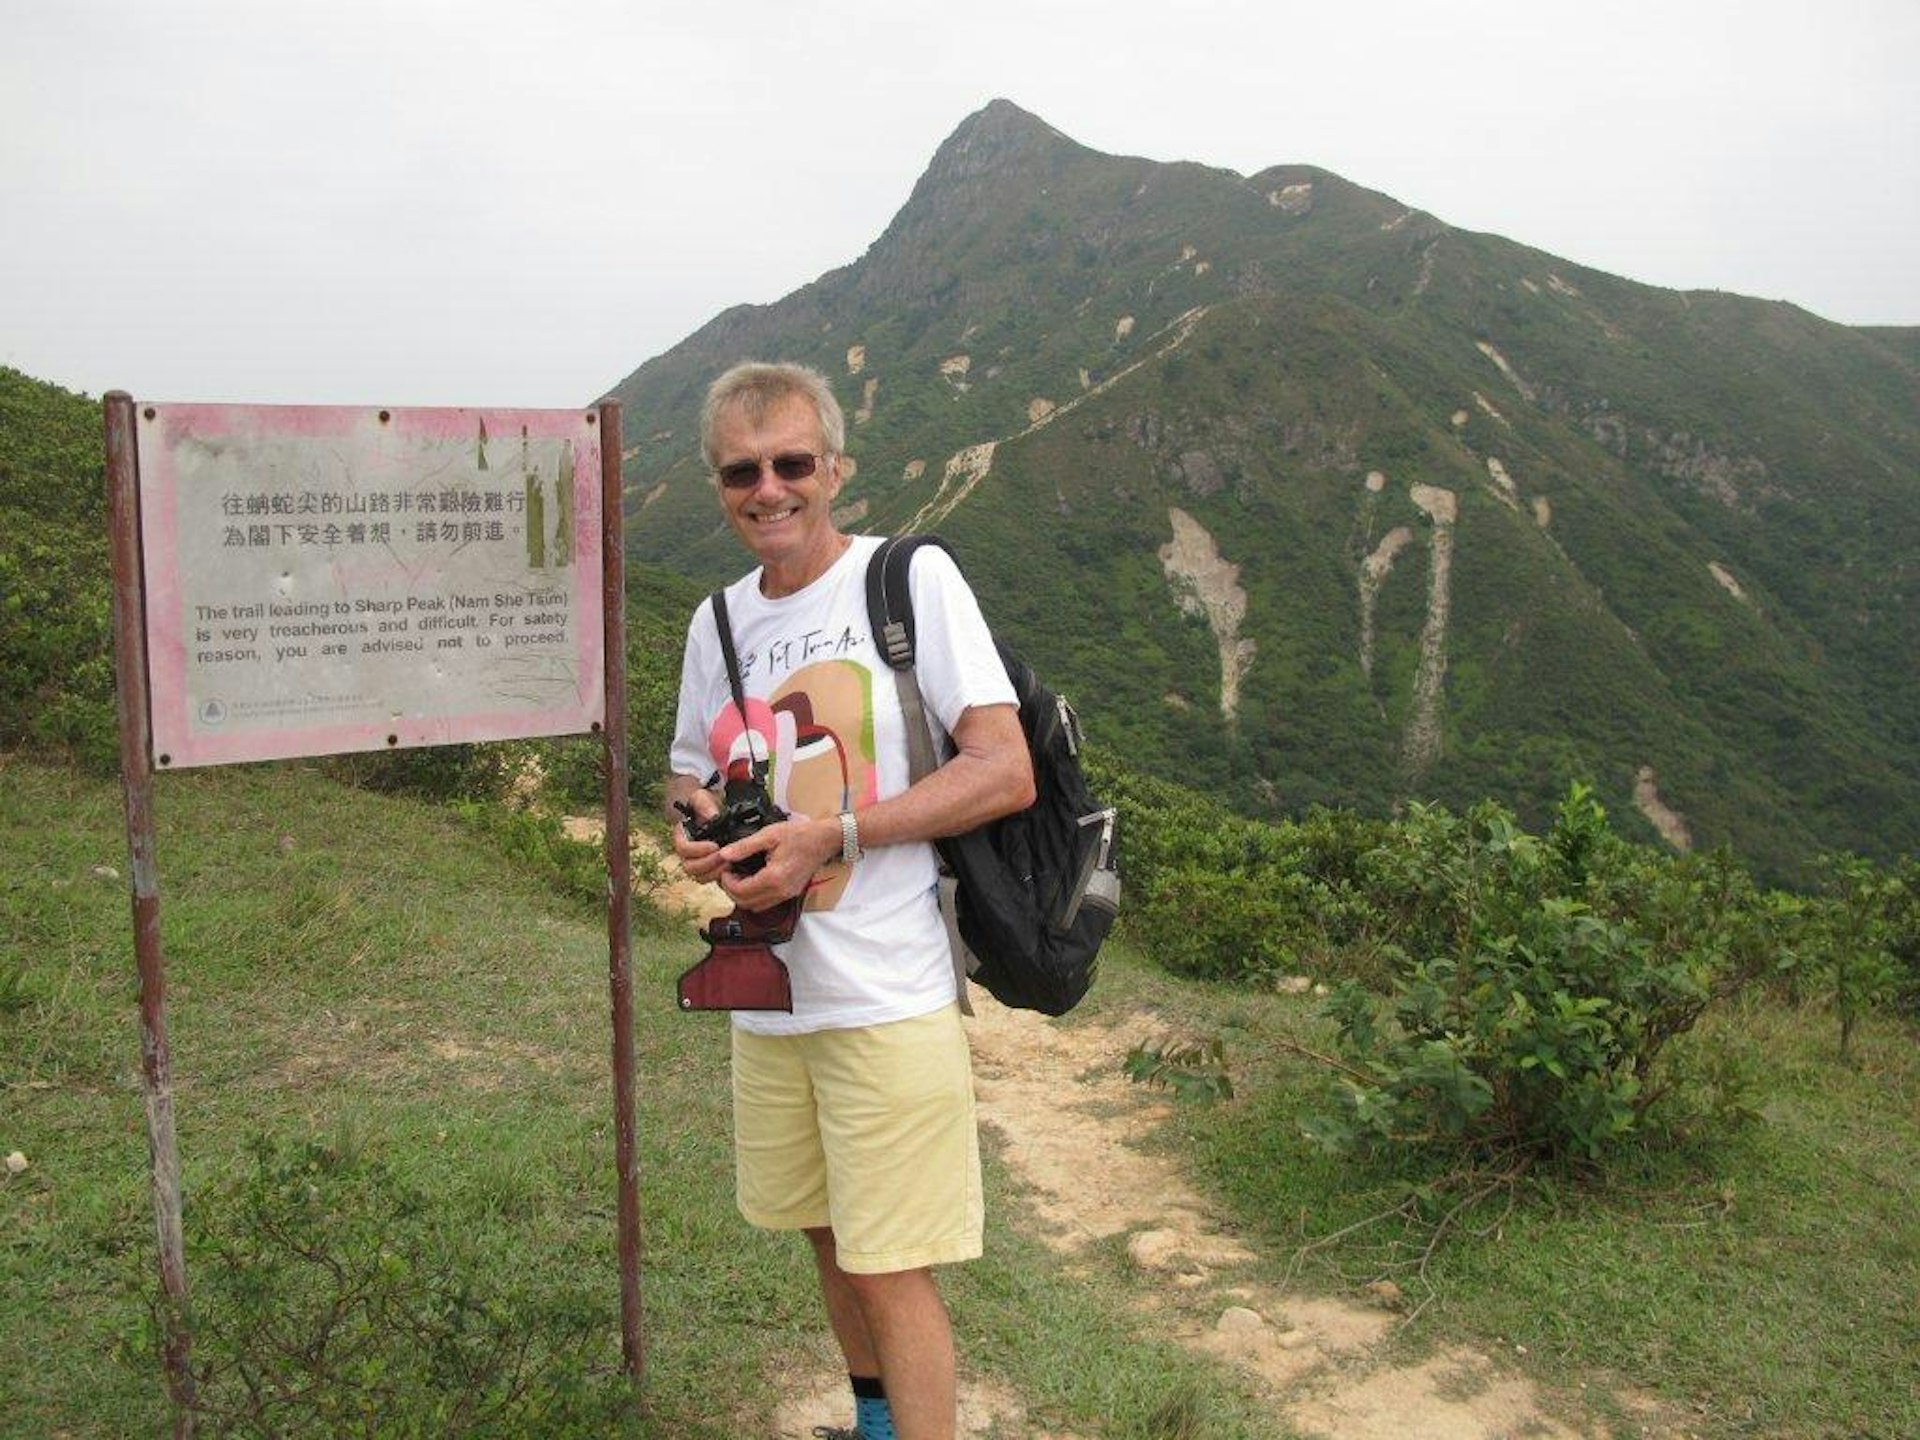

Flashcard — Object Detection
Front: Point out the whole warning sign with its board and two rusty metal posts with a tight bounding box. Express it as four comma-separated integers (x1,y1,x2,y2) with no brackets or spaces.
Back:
104,390,645,1436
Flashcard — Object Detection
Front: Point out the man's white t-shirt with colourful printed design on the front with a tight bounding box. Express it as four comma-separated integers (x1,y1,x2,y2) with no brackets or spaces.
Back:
670,536,1016,1035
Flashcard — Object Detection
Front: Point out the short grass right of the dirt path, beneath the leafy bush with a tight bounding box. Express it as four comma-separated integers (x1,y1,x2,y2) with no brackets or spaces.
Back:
1128,963,1920,1440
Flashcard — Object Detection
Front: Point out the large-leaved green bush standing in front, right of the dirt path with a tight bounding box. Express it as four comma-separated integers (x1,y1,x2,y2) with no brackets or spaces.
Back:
1308,785,1770,1160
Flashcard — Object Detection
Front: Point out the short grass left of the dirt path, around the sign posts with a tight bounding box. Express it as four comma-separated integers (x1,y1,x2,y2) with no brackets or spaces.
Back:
0,758,1275,1440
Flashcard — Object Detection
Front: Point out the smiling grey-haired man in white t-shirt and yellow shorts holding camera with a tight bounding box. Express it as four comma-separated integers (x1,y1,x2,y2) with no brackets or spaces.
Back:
668,365,1033,1440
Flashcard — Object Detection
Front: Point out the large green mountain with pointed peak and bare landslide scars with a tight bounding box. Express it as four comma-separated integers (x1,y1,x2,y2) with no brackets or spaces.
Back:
616,102,1920,877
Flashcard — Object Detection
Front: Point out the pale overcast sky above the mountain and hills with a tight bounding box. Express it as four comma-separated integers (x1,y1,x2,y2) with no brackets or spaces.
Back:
0,0,1920,407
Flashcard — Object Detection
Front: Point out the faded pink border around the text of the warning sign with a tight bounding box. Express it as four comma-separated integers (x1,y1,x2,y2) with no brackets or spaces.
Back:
134,401,607,770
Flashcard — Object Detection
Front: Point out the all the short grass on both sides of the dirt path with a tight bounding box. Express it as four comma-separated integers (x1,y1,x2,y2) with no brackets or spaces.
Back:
0,760,1920,1440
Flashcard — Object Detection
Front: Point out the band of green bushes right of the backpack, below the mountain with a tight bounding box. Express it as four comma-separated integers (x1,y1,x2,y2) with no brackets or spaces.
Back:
1091,753,1920,1113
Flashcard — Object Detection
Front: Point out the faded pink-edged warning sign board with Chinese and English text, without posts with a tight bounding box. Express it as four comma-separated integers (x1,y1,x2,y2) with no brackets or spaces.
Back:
136,403,607,770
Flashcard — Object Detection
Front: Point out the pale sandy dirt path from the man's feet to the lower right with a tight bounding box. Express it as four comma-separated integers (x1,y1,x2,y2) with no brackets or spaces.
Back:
772,1000,1684,1440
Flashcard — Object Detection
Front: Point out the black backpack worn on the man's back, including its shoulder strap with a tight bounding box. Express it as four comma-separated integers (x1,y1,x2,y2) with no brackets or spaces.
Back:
866,536,1119,1016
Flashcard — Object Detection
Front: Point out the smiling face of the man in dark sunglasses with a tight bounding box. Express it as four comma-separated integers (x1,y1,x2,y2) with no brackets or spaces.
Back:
712,396,841,589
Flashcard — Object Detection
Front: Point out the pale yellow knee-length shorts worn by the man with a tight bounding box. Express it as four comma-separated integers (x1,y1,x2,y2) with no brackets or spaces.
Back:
733,1004,985,1275
